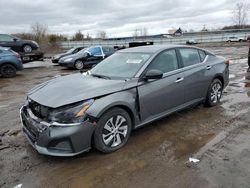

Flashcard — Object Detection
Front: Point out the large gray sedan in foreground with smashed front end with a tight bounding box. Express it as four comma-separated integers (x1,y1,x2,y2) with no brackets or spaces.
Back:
20,45,229,156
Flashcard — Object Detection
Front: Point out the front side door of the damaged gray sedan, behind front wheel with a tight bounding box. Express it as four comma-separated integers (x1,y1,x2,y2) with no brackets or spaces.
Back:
138,49,184,122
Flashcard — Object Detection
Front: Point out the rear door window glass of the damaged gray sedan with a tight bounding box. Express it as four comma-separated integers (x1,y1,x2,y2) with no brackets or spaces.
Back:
180,48,201,67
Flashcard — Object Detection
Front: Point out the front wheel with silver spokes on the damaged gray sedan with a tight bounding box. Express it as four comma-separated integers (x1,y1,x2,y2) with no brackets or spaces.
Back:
94,108,132,153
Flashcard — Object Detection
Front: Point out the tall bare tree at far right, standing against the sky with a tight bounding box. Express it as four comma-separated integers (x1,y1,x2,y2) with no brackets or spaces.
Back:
232,2,250,28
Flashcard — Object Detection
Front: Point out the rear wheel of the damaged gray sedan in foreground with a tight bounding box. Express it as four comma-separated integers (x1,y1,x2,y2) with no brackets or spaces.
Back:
205,79,223,107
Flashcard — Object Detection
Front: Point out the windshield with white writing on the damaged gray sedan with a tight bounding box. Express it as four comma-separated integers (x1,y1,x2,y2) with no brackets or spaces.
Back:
90,52,151,78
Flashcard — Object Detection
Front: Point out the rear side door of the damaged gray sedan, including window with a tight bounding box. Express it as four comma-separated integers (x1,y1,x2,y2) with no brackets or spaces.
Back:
178,48,211,103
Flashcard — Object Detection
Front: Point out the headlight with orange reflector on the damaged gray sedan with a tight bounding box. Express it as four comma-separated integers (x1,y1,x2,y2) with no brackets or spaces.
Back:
49,99,94,124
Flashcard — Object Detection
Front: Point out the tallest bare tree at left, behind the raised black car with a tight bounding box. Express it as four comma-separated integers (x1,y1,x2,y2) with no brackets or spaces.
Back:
31,22,48,44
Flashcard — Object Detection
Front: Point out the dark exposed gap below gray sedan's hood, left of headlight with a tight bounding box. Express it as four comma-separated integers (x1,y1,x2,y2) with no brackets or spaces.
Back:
29,100,49,119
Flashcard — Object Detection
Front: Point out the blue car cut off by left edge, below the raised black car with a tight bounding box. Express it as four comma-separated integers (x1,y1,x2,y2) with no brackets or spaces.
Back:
0,47,23,78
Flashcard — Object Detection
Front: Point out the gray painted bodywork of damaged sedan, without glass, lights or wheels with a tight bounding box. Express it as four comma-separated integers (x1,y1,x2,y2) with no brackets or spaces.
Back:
21,46,229,156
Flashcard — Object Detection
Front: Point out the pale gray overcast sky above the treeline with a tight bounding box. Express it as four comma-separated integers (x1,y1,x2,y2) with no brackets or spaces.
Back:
0,0,244,37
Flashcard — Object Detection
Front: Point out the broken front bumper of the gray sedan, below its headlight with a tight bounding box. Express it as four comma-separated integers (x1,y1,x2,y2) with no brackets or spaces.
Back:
20,106,95,157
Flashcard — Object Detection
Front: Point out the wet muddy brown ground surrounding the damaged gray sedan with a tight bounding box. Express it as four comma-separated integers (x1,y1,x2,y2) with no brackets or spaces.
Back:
0,46,250,188
